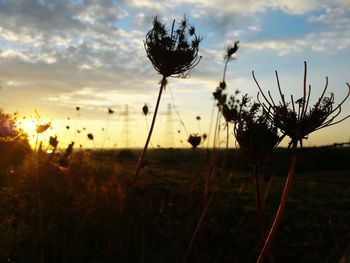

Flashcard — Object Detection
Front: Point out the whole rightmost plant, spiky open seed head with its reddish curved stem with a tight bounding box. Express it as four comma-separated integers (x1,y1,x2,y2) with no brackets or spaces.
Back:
253,62,350,262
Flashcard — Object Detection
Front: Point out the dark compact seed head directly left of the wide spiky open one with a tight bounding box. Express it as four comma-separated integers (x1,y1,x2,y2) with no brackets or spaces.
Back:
234,95,281,164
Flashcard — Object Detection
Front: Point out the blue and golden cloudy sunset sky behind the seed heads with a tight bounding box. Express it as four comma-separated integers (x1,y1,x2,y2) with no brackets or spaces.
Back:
0,0,350,148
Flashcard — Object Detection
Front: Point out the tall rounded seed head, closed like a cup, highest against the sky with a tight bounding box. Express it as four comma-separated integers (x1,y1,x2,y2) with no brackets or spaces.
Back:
144,16,202,78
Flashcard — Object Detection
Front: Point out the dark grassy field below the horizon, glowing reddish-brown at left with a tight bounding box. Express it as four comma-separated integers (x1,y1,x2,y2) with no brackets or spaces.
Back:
0,148,350,262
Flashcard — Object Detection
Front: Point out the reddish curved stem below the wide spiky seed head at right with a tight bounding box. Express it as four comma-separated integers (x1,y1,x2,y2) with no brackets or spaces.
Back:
257,142,298,263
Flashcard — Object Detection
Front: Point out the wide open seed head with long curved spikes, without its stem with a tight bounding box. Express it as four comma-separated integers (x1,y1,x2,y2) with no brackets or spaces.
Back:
253,62,350,146
